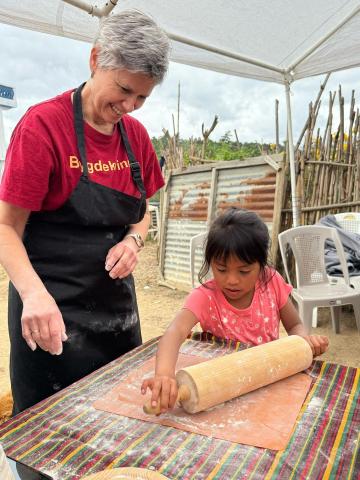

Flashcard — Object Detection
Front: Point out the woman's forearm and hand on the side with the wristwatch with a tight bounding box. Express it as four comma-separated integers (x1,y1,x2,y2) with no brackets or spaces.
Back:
105,200,150,279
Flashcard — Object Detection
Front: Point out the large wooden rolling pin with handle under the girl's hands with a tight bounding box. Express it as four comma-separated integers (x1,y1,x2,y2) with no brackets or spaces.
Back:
144,335,313,415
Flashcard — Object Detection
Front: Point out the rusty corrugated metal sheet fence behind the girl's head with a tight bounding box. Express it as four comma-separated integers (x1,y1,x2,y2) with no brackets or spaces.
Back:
160,157,284,289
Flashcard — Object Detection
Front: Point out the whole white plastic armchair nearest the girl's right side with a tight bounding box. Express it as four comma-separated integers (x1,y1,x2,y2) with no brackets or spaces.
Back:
279,225,360,333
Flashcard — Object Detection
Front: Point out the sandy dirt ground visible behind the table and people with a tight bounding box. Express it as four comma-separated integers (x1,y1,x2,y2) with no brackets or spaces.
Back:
0,241,360,418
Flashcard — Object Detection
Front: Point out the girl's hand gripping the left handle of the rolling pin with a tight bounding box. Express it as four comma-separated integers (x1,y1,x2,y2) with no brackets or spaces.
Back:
141,375,178,413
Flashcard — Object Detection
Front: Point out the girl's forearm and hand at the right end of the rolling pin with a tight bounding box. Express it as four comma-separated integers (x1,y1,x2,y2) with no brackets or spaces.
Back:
280,298,329,357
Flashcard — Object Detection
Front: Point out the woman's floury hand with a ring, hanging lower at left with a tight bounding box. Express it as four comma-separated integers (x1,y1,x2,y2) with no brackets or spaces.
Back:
21,289,67,355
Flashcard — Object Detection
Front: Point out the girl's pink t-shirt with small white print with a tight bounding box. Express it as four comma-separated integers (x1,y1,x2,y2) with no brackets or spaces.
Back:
184,269,292,345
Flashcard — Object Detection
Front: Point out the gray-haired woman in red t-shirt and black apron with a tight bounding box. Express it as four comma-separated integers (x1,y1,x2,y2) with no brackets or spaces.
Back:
0,11,169,413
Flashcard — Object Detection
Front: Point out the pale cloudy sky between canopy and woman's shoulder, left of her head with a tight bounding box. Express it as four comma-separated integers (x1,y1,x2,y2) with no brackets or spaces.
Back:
0,25,90,141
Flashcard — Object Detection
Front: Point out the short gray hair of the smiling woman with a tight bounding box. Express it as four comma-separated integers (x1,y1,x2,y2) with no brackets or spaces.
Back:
94,10,170,83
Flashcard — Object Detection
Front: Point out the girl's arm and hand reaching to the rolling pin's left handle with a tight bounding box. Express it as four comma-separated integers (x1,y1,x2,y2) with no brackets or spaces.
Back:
141,308,198,413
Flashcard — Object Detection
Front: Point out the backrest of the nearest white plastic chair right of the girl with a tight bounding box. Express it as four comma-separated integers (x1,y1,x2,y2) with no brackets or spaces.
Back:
279,225,350,287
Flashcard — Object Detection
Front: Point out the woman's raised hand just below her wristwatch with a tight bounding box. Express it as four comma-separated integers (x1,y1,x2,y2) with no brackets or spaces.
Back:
105,237,139,279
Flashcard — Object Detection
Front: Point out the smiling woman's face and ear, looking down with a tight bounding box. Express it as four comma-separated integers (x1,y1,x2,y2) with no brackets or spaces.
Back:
85,49,156,124
